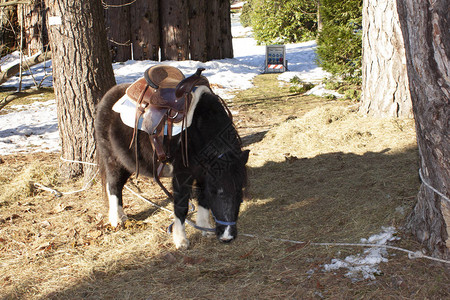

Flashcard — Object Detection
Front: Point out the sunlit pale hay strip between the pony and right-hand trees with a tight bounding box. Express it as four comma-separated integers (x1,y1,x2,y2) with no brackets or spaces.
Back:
250,106,416,167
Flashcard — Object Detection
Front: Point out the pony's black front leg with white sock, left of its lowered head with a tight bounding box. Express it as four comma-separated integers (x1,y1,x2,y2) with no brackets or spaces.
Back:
172,174,193,249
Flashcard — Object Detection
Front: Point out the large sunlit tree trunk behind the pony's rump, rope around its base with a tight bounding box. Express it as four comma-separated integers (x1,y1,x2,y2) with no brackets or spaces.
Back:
46,0,115,178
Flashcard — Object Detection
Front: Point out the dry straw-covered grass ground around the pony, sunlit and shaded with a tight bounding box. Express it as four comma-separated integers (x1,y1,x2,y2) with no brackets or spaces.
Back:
0,76,450,299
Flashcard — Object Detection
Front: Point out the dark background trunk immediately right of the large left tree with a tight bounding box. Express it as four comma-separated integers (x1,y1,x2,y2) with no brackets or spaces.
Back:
104,0,129,62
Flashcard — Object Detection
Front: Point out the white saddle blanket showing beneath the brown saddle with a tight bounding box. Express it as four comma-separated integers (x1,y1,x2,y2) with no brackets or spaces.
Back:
112,86,212,135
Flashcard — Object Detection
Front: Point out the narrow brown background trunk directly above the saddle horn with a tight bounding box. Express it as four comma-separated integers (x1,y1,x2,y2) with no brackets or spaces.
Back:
189,0,207,62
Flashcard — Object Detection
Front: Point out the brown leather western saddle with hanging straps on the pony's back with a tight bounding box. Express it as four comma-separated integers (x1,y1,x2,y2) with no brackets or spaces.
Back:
126,65,210,194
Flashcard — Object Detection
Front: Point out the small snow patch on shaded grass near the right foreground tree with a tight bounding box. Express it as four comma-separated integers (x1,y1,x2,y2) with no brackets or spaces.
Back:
324,227,398,281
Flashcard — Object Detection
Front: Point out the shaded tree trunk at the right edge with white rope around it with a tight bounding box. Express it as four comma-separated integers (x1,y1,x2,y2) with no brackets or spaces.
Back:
397,0,450,259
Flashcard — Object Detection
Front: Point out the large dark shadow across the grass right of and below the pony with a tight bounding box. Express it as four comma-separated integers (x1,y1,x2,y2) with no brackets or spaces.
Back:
6,149,442,299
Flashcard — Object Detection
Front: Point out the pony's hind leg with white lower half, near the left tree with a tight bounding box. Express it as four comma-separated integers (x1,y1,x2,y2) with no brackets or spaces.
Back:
105,170,130,227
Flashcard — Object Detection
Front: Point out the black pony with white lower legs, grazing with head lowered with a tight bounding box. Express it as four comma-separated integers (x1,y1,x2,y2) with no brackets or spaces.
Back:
94,84,249,249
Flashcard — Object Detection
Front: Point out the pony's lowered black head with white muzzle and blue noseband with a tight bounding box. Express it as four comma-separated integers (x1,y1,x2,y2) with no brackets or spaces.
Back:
204,150,249,243
